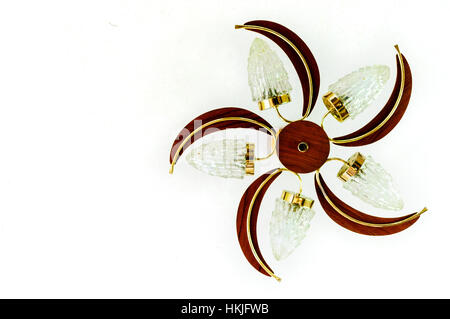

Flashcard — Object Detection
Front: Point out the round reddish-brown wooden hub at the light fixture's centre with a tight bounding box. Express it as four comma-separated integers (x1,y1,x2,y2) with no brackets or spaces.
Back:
277,121,330,173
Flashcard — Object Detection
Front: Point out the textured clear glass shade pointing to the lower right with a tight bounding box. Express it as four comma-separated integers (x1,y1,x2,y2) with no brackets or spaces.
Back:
343,156,403,210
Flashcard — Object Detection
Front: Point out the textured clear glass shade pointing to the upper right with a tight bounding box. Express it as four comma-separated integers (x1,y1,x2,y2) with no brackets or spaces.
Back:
329,65,389,118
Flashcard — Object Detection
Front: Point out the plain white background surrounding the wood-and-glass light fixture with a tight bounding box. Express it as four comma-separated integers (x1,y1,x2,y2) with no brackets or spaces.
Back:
0,0,450,298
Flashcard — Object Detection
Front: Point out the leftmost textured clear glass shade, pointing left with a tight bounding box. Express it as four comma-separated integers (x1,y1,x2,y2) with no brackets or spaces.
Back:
186,139,248,178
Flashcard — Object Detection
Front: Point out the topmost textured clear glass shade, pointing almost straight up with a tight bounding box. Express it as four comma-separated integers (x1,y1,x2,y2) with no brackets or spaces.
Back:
248,38,292,102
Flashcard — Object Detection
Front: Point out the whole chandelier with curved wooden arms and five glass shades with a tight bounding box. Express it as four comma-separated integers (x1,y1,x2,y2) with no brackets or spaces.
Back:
170,20,427,280
